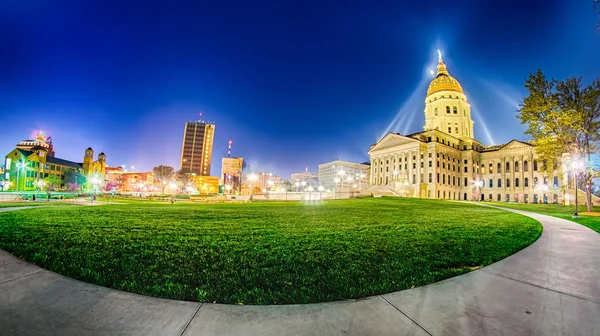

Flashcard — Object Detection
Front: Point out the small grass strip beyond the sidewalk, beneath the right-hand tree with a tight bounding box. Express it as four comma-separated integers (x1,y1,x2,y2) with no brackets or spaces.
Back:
486,202,600,233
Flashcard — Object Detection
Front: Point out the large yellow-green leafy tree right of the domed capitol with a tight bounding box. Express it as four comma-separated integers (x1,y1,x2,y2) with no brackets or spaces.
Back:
517,70,600,211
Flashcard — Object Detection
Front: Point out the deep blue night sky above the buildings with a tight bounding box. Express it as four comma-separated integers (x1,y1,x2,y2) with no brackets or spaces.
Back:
0,0,600,178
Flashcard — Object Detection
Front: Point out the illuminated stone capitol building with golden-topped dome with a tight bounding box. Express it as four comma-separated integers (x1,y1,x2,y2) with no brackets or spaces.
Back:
368,55,573,203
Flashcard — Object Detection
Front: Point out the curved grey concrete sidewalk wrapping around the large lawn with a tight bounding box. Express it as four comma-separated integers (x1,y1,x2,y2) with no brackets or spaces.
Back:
0,209,600,336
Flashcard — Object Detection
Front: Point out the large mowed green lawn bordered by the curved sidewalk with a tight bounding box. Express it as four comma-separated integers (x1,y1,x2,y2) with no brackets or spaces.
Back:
0,198,542,304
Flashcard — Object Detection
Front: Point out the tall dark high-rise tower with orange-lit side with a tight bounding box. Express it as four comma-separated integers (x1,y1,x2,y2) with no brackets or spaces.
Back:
180,121,215,176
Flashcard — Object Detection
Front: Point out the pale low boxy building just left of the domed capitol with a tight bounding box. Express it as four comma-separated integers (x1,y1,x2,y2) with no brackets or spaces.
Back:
319,160,370,190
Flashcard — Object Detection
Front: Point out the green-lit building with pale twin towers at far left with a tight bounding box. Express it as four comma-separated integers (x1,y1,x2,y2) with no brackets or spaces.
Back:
4,132,106,191
